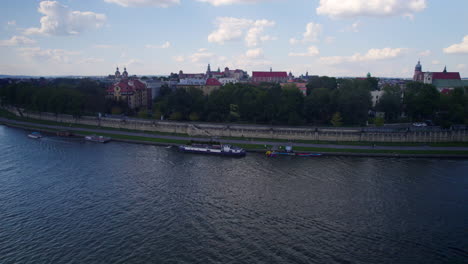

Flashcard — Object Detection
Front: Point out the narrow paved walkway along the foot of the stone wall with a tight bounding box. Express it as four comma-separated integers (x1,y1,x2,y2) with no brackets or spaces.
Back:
0,117,468,151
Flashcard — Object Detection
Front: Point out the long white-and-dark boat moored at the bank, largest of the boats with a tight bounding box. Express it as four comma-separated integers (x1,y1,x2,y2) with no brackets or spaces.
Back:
179,144,246,157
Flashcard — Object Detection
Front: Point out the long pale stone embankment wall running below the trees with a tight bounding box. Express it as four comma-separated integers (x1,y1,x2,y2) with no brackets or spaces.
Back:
7,107,468,143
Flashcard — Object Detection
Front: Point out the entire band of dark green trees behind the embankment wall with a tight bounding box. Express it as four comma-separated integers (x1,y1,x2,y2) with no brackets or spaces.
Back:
0,76,468,126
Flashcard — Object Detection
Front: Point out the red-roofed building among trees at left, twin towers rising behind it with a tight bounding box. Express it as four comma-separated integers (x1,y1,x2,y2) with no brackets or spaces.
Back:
106,68,152,109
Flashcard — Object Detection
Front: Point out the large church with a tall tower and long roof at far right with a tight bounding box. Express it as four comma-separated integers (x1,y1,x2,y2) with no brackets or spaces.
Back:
413,61,468,91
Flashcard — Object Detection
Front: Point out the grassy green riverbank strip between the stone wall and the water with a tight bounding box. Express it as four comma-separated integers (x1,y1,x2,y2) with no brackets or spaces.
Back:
0,117,468,159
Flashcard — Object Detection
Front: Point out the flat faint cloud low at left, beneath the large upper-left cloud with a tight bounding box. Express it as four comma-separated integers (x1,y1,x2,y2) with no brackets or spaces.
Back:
18,47,80,63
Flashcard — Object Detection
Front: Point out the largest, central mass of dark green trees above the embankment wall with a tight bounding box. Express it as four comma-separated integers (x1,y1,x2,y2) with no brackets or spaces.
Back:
154,78,371,125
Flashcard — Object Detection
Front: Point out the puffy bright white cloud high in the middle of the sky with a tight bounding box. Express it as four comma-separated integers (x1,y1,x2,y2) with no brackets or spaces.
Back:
208,17,275,47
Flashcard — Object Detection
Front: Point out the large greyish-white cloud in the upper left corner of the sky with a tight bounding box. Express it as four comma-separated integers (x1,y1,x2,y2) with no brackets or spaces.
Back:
25,1,106,35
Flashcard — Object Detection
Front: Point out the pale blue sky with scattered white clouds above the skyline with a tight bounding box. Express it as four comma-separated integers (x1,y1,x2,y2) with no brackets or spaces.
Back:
0,0,468,78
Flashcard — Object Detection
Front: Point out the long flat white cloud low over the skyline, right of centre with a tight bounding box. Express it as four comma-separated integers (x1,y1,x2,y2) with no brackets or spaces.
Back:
320,48,407,65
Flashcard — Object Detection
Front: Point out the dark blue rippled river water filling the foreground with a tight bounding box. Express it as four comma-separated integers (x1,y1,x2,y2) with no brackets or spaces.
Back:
0,126,468,264
